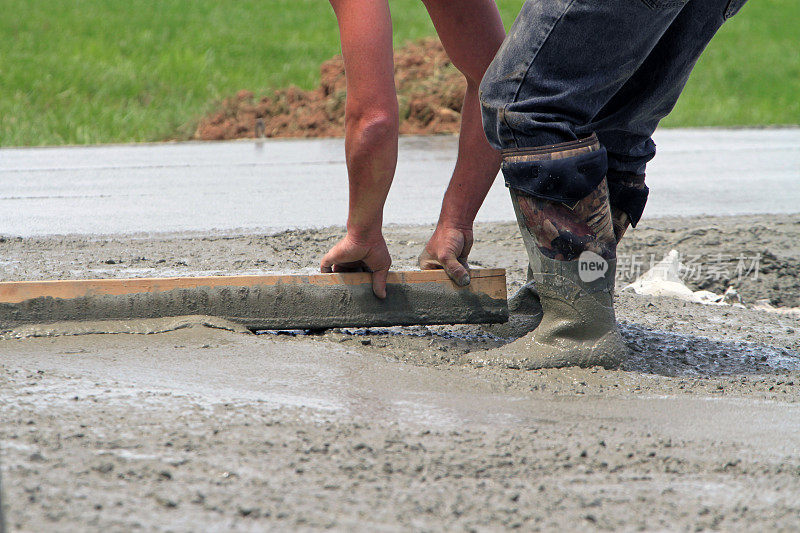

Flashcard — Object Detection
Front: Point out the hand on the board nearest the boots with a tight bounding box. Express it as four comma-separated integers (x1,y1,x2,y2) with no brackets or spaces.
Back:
418,225,472,287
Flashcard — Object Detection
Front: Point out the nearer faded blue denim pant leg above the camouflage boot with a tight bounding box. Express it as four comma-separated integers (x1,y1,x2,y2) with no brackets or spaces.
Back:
481,0,684,149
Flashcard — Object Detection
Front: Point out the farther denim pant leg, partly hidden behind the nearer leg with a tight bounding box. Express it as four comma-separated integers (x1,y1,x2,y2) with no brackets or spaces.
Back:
578,0,746,177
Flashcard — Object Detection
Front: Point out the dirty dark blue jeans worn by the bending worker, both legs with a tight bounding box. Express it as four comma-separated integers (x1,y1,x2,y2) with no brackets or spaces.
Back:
481,0,746,225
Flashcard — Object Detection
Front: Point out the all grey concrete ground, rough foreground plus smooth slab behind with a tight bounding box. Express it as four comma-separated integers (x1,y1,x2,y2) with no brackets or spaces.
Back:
0,130,800,531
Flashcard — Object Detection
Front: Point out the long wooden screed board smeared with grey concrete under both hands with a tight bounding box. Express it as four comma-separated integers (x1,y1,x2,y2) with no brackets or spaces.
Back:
0,269,508,329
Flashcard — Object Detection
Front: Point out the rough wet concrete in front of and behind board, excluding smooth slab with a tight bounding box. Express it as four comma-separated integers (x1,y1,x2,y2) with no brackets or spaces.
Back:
0,216,800,531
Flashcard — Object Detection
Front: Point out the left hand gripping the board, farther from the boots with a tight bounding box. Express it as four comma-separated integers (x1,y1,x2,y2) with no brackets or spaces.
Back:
320,233,392,299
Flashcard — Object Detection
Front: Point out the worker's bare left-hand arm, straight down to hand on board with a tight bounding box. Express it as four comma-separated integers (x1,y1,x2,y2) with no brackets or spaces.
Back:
321,0,399,298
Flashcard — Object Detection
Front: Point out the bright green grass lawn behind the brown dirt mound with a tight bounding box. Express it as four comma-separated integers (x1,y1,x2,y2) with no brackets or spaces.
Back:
0,0,800,146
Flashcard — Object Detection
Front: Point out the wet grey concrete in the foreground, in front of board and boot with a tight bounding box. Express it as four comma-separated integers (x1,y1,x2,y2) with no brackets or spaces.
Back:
0,320,800,532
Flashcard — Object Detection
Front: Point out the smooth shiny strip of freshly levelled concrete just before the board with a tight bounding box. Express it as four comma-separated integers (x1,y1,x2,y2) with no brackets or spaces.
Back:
0,327,800,455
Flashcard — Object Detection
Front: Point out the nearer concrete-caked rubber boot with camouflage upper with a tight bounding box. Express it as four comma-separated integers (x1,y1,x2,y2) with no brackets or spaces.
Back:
466,138,626,369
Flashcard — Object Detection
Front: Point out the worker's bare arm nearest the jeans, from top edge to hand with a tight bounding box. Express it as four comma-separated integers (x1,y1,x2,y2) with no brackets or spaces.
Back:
419,0,505,285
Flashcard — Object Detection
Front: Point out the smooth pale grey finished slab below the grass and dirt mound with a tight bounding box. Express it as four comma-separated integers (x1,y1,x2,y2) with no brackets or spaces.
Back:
0,128,800,236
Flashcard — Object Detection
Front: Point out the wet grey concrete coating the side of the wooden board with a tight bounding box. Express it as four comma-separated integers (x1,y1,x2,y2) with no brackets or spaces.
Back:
0,272,508,333
